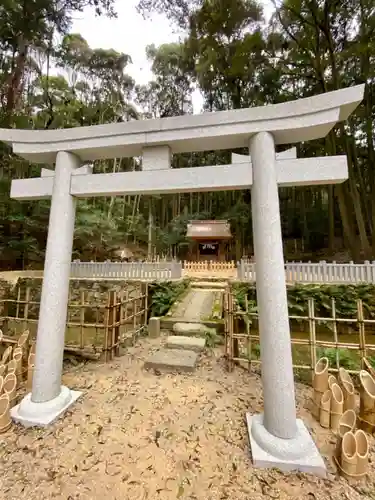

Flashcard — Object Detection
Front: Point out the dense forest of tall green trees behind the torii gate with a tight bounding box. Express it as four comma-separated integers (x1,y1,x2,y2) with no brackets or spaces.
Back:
0,0,375,269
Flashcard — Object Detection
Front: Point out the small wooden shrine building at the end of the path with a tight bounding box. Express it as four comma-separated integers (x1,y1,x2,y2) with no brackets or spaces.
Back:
186,220,232,261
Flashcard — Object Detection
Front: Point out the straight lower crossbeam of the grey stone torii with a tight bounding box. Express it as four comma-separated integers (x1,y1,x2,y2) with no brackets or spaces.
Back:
11,156,348,200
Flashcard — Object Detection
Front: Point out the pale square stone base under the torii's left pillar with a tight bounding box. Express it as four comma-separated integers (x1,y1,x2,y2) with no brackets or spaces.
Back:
10,386,82,427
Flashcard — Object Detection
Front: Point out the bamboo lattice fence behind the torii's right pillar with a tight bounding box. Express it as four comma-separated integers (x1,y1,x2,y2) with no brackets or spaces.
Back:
224,288,375,374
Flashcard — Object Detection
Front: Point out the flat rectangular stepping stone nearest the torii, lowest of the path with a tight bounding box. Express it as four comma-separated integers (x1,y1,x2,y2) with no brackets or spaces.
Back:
144,349,198,372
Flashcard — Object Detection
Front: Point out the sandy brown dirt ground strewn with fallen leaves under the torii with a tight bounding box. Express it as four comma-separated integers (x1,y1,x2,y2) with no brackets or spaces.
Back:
0,339,375,500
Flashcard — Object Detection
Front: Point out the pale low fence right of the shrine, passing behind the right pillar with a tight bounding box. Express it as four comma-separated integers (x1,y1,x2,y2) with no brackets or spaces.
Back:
237,260,375,284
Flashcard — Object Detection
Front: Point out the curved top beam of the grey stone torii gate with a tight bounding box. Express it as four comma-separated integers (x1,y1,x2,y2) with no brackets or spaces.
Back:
0,85,364,163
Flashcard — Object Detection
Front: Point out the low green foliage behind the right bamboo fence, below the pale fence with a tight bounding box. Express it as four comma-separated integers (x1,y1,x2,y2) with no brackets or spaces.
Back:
234,283,375,318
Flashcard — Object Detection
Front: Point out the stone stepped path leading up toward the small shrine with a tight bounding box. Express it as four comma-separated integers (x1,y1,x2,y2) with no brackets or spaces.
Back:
144,281,226,372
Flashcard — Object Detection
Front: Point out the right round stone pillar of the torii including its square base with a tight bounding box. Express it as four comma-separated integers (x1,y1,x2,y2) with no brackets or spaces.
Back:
246,132,326,477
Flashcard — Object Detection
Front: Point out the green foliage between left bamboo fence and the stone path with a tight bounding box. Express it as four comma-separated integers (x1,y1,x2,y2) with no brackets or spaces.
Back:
149,280,190,316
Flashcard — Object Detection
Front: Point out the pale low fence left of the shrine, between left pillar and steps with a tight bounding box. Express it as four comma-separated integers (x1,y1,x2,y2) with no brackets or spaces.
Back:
70,261,182,280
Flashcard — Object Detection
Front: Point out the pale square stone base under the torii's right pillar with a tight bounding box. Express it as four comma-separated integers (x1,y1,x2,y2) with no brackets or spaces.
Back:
246,413,327,478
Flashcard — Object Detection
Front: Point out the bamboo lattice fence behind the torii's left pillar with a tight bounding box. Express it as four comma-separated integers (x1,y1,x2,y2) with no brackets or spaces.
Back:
0,283,148,361
